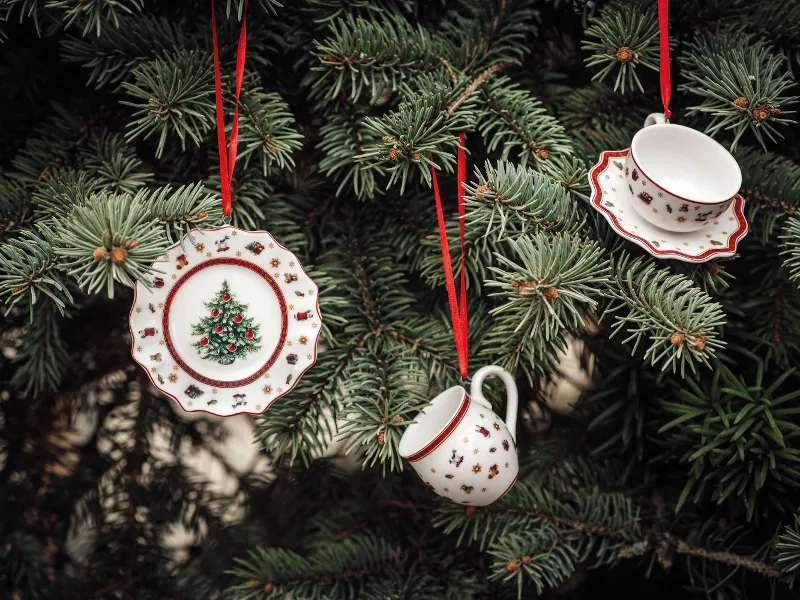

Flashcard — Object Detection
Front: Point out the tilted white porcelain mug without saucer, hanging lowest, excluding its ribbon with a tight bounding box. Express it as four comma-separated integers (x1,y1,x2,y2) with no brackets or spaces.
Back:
399,365,519,506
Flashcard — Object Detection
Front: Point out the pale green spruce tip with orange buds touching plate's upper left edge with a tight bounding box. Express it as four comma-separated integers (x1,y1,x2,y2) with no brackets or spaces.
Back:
56,192,167,298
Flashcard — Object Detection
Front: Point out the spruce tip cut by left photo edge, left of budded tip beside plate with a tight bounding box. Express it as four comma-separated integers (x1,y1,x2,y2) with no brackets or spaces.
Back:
0,224,73,322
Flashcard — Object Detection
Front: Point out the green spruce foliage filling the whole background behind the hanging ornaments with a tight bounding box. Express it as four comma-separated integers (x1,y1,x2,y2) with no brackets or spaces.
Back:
0,0,800,600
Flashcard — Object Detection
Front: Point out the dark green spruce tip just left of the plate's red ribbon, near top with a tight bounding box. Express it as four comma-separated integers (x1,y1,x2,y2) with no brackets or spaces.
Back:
121,51,214,157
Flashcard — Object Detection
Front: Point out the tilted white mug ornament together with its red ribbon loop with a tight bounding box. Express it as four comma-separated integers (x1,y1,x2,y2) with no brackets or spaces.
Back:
398,134,519,506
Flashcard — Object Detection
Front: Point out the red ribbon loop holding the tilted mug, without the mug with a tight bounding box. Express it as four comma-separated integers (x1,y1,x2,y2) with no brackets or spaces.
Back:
431,133,469,377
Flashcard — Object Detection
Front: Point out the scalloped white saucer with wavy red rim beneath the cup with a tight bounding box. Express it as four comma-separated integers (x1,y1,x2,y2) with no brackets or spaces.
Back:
589,150,747,263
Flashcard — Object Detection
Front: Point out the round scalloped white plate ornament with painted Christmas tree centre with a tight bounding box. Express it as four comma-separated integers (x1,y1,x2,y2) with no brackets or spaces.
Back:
129,226,322,416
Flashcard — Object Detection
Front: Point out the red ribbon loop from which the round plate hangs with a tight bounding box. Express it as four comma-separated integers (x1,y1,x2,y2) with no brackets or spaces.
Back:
211,0,247,217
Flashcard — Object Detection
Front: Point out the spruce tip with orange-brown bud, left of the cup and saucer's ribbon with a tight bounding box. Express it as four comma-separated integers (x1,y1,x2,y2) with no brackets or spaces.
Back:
581,2,659,94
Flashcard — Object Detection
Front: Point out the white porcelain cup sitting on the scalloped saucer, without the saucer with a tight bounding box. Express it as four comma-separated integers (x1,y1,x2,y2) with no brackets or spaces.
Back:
625,113,742,231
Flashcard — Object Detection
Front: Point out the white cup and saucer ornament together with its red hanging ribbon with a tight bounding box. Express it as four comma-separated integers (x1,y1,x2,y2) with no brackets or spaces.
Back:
589,0,747,263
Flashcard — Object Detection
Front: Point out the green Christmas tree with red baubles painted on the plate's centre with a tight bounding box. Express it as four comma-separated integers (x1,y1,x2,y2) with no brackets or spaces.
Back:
192,280,261,365
